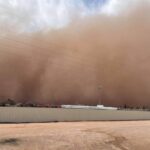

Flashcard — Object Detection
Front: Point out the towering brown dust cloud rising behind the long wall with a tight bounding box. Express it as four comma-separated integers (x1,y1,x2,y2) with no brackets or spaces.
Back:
0,0,150,106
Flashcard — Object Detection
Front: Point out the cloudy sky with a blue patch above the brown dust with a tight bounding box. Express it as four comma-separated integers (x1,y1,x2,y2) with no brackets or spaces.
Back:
0,0,135,32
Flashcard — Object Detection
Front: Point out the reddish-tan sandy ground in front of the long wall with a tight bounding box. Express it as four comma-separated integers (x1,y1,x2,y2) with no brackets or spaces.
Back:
0,121,150,150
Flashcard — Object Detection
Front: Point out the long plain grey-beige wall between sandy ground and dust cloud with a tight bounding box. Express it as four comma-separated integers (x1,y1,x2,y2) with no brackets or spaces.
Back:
0,107,150,123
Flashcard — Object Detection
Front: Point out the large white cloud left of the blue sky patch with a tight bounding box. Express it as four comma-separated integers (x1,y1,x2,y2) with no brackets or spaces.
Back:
0,0,88,31
